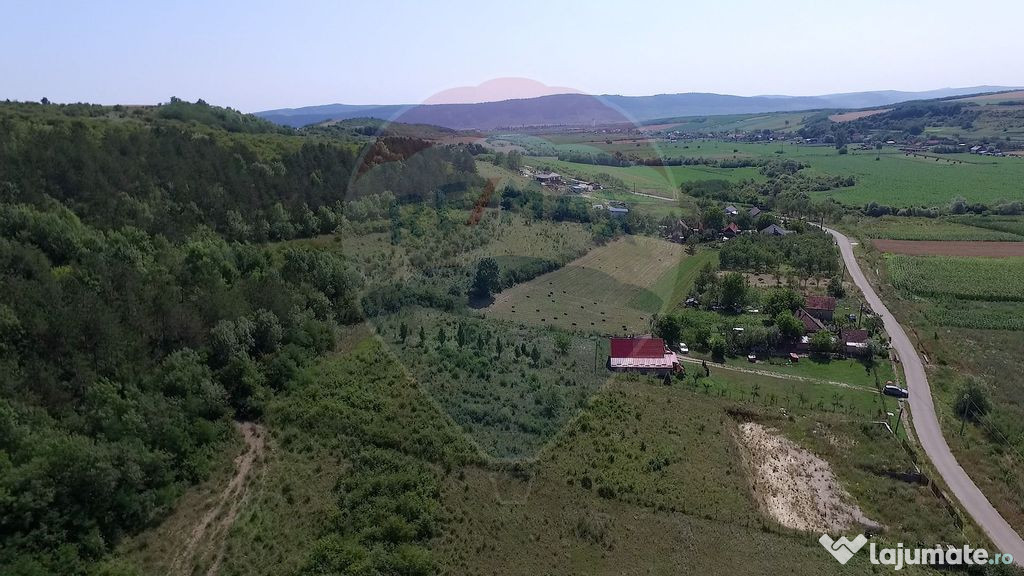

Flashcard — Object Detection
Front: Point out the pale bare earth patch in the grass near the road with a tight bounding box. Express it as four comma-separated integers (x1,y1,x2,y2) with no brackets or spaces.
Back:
739,422,879,532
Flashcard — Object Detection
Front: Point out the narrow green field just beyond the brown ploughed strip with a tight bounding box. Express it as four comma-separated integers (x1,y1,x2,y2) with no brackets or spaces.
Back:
855,216,1024,242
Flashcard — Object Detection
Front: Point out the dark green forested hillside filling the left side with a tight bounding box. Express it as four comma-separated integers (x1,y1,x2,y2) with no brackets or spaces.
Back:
0,100,482,575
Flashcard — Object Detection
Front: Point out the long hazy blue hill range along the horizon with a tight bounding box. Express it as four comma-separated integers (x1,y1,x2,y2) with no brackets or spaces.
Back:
256,86,1013,130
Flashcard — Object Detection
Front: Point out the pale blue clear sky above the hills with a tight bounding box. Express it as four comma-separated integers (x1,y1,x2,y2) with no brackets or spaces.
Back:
0,0,1024,112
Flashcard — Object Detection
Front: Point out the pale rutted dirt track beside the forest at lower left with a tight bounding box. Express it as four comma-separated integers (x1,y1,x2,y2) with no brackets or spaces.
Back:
171,422,266,576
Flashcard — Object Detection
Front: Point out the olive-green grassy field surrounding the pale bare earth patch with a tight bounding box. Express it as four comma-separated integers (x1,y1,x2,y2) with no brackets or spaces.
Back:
435,377,964,575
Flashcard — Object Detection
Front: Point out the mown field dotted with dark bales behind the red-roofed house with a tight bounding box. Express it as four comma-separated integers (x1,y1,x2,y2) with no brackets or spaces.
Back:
485,237,715,333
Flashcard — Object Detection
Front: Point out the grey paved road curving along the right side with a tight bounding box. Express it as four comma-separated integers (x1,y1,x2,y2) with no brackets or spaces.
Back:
825,224,1024,564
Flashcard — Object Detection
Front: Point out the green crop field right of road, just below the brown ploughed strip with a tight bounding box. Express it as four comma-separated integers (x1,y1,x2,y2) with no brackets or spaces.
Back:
886,254,1024,301
